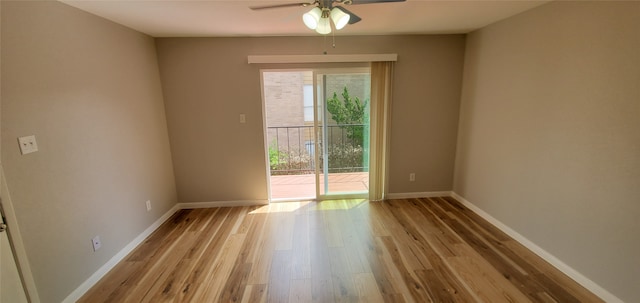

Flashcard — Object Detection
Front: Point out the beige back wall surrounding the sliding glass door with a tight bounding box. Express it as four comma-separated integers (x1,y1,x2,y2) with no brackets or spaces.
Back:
156,35,465,202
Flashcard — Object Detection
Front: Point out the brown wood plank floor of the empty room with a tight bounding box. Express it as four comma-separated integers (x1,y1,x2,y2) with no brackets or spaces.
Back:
80,197,602,302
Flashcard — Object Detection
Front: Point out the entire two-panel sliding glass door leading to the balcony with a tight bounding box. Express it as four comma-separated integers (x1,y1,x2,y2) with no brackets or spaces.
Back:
262,68,371,200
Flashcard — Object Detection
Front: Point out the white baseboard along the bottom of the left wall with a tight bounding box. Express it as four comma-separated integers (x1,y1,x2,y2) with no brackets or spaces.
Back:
62,204,179,303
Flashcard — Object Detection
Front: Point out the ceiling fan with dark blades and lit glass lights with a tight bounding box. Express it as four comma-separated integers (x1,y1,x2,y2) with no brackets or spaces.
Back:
250,0,406,35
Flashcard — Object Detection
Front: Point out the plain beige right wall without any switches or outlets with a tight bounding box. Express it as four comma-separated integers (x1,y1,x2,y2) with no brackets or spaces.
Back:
454,2,640,302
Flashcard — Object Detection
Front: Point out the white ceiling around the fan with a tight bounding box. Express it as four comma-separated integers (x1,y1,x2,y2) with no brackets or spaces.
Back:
59,0,548,37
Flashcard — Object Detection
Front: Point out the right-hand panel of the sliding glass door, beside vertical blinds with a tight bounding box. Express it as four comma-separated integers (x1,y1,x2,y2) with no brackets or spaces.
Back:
314,69,371,198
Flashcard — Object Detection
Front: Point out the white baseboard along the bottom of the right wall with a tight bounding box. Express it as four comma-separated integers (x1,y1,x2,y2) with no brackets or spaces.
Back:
451,192,624,303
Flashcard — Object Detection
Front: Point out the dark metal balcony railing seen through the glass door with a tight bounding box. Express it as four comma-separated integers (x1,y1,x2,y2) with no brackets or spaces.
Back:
267,124,368,175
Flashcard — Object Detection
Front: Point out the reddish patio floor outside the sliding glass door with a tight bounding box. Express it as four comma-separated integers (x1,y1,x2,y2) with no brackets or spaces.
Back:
271,172,369,199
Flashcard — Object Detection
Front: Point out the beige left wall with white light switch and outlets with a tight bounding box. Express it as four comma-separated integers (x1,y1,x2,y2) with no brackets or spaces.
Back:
1,1,176,302
